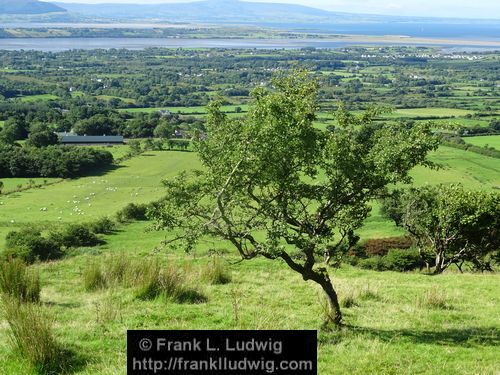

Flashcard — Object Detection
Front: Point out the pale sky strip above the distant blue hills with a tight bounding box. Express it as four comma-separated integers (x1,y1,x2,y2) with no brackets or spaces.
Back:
46,0,500,19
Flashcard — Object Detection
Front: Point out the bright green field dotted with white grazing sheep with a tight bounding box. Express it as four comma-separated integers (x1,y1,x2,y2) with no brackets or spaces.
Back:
0,151,196,243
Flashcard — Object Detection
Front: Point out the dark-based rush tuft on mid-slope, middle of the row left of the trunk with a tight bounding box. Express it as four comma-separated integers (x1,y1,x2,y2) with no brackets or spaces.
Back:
136,267,207,303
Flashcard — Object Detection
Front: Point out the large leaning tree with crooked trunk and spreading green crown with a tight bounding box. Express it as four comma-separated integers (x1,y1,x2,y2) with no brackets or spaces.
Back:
152,71,436,325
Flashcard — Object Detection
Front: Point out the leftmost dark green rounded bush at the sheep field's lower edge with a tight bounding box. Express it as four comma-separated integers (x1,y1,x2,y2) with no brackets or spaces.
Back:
4,228,63,263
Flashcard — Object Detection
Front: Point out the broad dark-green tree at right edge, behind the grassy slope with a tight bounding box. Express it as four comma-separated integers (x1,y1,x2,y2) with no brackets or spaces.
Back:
382,185,500,274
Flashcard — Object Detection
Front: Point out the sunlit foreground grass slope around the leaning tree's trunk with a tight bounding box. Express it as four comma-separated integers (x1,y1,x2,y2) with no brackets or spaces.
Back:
0,223,500,375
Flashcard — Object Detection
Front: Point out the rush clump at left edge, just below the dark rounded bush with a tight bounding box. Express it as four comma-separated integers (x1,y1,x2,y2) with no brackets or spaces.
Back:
0,259,40,302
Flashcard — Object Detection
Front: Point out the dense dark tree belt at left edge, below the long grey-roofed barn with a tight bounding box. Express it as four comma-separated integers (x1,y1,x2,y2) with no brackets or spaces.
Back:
0,144,113,178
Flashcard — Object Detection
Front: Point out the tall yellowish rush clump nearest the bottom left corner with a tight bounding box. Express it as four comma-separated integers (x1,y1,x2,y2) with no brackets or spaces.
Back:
4,298,62,374
